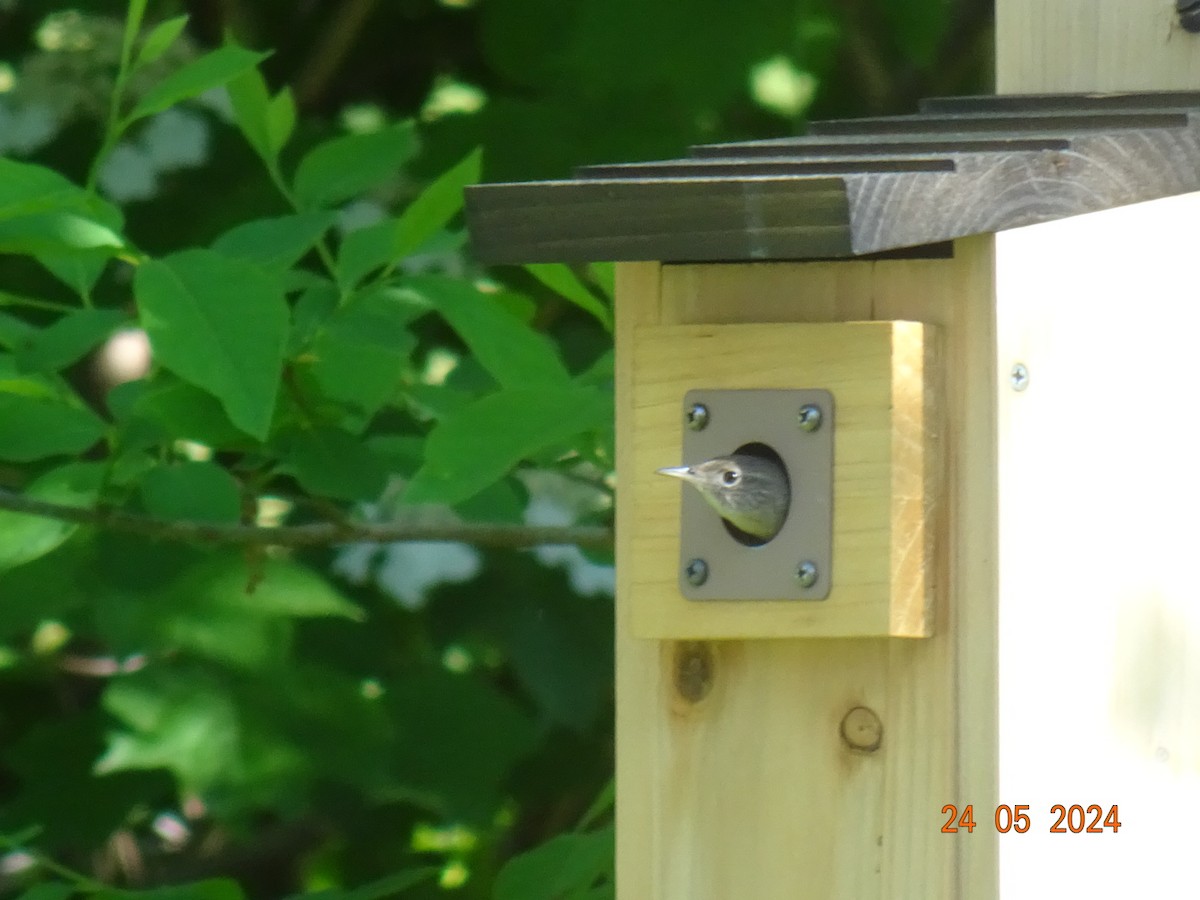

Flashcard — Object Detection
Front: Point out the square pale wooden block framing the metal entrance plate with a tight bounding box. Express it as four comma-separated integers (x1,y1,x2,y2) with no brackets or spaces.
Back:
624,322,942,640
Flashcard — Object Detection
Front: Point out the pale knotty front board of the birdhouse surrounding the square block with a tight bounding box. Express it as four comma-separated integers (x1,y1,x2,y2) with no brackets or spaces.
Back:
617,239,996,900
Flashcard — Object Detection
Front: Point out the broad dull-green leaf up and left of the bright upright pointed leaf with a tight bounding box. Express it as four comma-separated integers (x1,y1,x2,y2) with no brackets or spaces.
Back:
295,122,416,209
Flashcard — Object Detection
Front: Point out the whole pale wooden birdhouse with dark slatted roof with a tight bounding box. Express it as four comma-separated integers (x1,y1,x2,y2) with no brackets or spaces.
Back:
468,0,1200,900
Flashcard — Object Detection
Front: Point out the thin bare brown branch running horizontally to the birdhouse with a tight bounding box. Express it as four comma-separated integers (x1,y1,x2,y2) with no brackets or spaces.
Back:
0,490,612,548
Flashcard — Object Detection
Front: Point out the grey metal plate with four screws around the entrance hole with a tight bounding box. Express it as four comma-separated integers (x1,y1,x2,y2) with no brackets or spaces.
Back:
679,390,834,600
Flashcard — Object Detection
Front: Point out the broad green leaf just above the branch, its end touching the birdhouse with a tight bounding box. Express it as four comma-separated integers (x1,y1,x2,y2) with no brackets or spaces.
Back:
404,386,612,504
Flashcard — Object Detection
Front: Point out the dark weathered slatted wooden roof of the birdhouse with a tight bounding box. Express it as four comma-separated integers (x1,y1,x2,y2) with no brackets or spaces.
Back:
467,91,1200,263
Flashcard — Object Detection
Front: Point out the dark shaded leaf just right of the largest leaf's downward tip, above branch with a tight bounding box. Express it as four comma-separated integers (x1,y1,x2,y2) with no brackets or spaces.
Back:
280,427,388,500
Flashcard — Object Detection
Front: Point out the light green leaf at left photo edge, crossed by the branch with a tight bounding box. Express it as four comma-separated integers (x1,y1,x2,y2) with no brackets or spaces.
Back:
0,462,104,571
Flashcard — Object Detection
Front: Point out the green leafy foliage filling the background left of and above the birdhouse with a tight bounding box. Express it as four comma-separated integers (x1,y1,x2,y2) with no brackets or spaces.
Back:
0,0,990,900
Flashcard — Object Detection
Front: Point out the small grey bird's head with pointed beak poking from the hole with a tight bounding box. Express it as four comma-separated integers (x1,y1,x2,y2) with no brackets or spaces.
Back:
659,454,792,541
